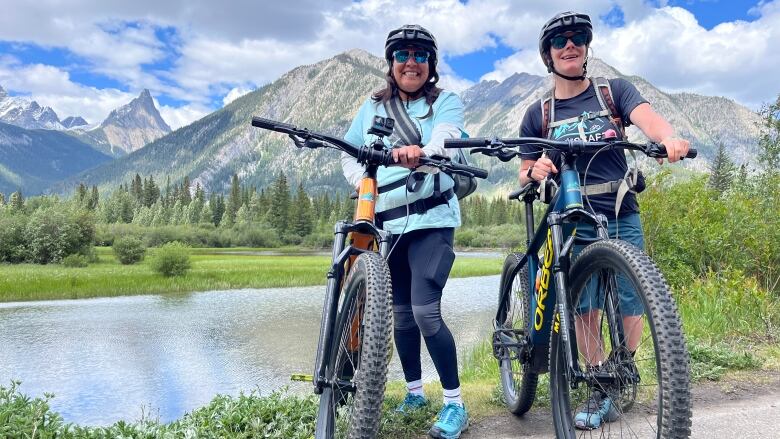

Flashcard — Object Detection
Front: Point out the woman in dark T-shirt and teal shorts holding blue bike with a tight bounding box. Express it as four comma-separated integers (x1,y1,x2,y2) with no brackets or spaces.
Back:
520,12,689,429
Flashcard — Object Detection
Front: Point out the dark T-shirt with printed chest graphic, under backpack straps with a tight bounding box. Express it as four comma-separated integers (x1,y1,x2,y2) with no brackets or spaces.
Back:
520,79,647,218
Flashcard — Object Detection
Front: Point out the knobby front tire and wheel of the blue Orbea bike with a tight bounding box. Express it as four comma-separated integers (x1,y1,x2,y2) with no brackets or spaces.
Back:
550,240,691,438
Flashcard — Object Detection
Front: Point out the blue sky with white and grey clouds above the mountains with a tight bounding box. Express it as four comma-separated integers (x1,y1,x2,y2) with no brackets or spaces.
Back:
0,0,780,129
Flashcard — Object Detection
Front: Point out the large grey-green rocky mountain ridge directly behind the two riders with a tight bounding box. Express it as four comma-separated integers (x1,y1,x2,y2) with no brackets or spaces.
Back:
63,50,759,196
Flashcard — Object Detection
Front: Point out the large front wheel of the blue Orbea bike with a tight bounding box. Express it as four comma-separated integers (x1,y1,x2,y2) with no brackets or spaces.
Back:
550,240,691,438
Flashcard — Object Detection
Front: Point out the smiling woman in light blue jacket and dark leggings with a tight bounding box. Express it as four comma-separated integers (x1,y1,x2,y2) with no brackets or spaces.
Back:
341,25,468,438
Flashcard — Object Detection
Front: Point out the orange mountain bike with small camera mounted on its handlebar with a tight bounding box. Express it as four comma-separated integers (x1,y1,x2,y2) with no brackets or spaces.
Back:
252,116,487,439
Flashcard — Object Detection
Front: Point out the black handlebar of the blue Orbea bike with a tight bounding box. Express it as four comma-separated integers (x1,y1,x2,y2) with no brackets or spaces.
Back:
444,137,698,161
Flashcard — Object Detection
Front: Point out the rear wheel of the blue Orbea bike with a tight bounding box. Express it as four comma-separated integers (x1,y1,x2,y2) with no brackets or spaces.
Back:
493,253,539,415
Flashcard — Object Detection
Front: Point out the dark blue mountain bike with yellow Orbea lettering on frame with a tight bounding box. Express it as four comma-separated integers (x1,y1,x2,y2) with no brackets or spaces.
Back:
445,138,696,438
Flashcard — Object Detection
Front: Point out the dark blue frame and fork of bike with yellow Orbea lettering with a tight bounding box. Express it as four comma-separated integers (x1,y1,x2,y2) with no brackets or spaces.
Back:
494,153,623,382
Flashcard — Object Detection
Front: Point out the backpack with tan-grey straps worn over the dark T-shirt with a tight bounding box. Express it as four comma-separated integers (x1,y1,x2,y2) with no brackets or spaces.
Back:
541,76,645,218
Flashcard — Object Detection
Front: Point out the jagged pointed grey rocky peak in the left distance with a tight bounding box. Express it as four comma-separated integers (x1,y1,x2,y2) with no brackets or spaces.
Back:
74,90,171,157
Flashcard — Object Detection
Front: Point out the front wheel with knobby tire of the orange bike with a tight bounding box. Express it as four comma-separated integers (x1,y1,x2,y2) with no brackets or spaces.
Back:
315,253,392,439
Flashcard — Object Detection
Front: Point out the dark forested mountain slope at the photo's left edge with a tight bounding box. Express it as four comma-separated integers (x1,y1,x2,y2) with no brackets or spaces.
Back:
0,122,111,195
